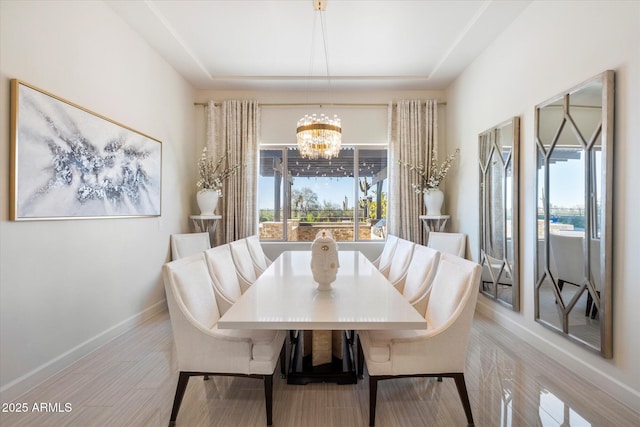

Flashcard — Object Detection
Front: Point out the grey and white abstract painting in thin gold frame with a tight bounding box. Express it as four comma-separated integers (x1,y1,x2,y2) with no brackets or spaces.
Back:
11,79,162,220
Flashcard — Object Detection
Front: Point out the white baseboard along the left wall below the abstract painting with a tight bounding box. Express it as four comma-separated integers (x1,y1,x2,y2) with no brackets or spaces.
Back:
0,300,167,402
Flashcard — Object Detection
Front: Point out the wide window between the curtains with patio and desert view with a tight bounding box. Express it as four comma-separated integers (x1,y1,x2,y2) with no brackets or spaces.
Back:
258,147,388,241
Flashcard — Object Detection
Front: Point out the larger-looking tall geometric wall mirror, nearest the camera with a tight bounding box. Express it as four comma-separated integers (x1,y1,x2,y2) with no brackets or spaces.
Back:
535,71,614,358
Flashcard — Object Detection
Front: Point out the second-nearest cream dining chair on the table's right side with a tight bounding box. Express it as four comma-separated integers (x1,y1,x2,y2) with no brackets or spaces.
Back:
397,245,440,313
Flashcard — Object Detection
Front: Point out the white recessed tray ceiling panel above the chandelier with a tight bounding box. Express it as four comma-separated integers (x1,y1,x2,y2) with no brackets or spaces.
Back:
106,0,531,91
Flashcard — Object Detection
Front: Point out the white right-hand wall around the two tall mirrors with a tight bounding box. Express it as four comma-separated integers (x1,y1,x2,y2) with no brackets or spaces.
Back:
447,1,640,410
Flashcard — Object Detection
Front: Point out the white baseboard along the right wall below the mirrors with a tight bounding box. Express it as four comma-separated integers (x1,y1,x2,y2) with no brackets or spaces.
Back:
476,298,640,412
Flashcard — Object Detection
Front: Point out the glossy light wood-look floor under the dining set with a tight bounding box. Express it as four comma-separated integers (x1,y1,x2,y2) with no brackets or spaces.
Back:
0,312,640,427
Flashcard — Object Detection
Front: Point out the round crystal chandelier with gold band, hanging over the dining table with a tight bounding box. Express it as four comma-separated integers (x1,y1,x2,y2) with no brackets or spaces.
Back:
296,0,342,160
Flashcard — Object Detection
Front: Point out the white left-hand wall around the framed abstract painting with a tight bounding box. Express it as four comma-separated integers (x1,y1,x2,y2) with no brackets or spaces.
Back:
0,1,197,402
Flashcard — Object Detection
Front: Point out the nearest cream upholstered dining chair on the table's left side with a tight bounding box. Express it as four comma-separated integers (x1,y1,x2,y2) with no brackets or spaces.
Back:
162,253,285,426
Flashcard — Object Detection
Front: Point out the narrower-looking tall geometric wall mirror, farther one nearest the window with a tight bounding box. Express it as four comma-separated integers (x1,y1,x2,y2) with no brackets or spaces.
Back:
478,117,520,311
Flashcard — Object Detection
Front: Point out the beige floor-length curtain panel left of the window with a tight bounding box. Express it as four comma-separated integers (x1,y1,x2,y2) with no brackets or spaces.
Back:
206,100,260,244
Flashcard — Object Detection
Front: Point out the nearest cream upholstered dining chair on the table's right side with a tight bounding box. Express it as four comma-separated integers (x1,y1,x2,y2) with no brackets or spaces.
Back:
358,253,482,426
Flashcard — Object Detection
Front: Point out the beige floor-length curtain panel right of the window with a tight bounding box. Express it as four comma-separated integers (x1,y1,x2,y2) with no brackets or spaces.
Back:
387,100,438,244
